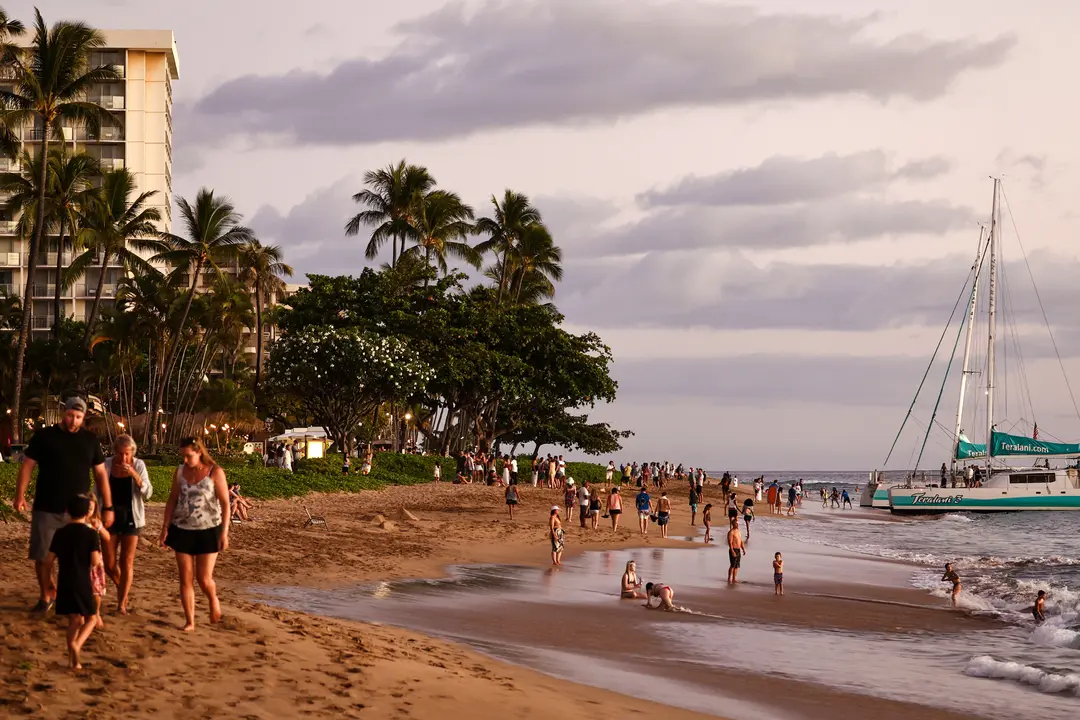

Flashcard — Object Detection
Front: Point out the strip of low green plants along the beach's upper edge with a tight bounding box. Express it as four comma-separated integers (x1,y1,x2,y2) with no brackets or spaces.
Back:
0,452,604,505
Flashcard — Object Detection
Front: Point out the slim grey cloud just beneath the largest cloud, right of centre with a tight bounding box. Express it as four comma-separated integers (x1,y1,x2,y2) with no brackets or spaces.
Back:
638,150,949,207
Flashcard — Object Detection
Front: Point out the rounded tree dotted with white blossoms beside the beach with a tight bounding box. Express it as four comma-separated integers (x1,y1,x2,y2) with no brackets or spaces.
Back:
267,327,434,453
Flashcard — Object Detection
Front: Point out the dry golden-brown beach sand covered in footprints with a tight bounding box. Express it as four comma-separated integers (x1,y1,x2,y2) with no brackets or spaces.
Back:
0,484,989,720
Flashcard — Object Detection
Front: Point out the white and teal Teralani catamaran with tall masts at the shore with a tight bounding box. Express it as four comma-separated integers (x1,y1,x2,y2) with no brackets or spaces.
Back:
881,183,1080,514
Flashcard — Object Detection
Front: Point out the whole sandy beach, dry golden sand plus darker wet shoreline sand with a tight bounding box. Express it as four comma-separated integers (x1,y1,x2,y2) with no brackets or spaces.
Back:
0,485,1045,720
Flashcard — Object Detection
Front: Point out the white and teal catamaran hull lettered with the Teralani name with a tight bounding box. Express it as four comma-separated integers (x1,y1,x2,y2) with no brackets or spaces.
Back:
889,488,1080,515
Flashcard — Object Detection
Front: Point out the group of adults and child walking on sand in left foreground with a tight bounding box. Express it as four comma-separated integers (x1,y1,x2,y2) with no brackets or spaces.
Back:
14,397,233,669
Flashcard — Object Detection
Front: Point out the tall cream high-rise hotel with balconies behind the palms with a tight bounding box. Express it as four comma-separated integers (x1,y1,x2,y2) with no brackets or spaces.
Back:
0,30,179,331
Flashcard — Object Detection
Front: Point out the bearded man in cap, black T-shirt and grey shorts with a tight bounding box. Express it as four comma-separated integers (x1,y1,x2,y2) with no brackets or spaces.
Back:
14,397,112,612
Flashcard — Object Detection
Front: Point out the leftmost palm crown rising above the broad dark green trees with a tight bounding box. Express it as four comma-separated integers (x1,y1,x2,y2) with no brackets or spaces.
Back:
345,160,435,267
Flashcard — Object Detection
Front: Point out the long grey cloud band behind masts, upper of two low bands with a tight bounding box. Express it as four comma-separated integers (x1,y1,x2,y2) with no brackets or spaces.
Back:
555,253,1080,336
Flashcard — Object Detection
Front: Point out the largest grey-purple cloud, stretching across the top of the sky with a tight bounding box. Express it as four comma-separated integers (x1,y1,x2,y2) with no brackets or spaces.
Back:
181,0,1014,145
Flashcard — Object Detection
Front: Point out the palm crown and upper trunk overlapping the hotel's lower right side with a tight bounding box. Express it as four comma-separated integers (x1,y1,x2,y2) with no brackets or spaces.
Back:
65,167,163,345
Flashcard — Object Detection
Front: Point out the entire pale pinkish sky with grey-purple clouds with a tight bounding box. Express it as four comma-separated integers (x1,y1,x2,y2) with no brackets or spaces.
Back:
19,0,1080,471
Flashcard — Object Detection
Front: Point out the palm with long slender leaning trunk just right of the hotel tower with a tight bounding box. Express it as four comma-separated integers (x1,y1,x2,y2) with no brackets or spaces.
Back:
150,188,255,449
